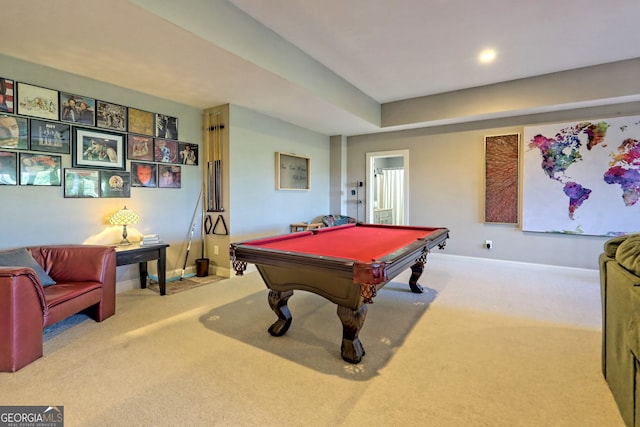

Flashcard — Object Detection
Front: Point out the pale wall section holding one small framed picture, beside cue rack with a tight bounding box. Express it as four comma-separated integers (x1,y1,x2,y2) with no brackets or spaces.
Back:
229,105,330,241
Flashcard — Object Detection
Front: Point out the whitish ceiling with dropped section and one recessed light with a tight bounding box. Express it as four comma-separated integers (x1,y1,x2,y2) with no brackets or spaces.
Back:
0,0,640,135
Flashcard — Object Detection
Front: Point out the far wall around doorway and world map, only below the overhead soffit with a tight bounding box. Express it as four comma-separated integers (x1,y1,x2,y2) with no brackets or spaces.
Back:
347,103,640,269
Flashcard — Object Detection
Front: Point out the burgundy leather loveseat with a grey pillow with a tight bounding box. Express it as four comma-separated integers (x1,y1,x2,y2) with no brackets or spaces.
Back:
0,245,116,372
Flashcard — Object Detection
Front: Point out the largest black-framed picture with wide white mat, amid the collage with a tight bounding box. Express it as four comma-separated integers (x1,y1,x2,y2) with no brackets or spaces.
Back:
72,127,125,170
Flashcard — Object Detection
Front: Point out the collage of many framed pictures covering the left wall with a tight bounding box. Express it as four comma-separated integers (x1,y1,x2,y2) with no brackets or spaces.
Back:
0,77,198,198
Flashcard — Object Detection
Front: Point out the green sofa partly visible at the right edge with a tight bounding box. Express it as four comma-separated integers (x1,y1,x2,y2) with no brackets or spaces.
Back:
599,234,640,426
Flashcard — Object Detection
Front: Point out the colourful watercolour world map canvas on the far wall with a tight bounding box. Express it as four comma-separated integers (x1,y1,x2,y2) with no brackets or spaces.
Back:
522,116,640,236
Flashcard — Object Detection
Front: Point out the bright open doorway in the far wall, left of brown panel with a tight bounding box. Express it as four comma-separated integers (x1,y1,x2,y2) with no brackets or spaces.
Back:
366,150,409,225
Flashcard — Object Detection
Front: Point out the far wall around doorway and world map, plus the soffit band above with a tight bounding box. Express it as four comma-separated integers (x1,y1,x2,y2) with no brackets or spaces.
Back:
347,59,640,269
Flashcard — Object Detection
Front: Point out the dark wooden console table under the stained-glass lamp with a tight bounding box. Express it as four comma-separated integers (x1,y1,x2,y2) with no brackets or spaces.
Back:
116,243,169,295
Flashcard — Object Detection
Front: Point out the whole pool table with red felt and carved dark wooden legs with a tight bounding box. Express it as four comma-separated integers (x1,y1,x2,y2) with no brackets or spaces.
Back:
229,223,449,363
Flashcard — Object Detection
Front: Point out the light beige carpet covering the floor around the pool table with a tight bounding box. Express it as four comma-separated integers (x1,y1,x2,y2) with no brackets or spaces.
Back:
0,253,623,427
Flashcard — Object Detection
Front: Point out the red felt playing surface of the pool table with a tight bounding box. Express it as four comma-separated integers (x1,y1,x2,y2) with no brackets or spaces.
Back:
239,224,442,262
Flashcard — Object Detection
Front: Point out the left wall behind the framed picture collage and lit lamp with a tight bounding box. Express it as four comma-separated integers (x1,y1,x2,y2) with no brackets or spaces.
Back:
0,55,202,291
